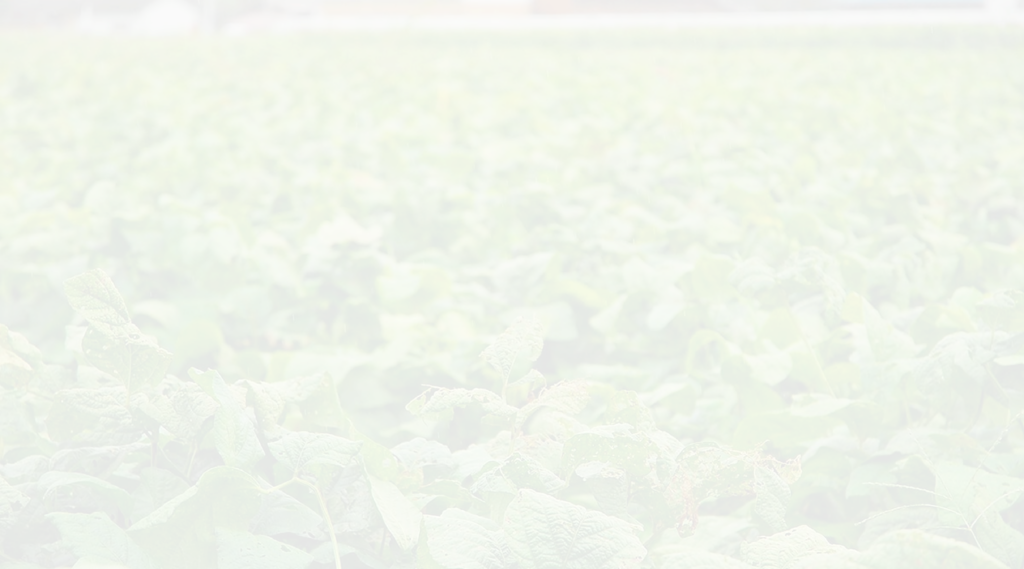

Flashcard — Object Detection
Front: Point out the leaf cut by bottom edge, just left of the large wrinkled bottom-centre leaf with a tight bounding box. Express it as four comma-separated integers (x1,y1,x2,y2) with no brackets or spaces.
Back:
416,510,517,569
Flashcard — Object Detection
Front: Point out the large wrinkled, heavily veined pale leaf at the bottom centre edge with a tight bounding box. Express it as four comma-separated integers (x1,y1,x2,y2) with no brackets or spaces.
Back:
504,490,647,569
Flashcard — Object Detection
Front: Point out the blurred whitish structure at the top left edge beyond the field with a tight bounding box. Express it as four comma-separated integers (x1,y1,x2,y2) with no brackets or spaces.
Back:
76,0,202,36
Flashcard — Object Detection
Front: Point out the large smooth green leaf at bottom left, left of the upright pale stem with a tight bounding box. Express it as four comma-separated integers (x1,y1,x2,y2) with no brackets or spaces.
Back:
128,467,262,569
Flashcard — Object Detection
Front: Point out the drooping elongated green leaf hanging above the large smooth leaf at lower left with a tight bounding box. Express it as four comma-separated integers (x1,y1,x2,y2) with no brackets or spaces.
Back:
188,367,264,471
